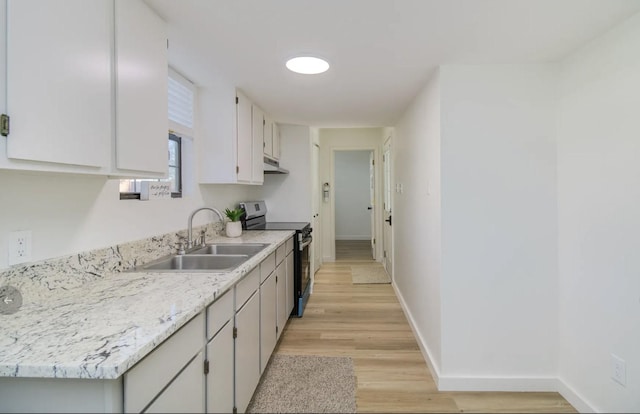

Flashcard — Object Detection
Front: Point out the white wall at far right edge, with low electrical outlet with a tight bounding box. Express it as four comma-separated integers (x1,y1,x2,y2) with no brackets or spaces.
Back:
558,14,640,412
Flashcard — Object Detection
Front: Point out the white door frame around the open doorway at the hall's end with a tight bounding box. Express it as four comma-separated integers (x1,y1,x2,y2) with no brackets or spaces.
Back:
323,146,382,262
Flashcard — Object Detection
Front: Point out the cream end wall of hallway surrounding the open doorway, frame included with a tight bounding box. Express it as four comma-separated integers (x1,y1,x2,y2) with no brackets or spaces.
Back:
319,128,382,261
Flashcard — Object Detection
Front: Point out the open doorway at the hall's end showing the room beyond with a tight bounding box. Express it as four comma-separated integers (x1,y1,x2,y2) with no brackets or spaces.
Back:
334,150,375,260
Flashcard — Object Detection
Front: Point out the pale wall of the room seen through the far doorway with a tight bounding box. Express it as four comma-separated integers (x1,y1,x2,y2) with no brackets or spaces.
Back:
334,151,372,240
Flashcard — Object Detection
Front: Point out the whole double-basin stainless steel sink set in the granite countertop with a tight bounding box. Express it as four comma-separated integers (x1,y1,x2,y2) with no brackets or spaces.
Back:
133,243,268,273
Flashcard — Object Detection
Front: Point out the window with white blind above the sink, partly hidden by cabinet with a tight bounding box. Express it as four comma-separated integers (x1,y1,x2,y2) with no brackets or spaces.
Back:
120,68,195,200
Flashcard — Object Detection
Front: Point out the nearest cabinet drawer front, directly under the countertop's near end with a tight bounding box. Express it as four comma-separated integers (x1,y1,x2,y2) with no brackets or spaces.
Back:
124,312,204,413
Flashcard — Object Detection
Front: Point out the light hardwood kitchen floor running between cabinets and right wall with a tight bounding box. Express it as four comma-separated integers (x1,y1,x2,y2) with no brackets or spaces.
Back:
276,260,575,413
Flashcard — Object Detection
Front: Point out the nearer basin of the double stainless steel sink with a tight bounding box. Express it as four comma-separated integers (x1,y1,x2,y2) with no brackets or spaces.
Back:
136,254,249,272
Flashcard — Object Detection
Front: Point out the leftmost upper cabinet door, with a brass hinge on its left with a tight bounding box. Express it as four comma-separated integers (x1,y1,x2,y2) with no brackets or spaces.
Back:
7,0,113,170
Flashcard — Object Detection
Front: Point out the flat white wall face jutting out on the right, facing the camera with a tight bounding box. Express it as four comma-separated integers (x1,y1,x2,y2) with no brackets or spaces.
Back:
440,65,557,386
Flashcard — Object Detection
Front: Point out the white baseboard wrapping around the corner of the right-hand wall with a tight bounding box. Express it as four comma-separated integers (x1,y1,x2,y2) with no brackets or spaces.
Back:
392,283,576,398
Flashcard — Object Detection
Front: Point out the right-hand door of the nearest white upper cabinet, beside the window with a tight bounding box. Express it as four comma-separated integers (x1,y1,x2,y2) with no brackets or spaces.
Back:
115,0,169,176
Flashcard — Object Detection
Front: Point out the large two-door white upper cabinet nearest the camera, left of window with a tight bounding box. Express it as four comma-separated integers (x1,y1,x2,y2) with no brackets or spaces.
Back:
0,0,167,177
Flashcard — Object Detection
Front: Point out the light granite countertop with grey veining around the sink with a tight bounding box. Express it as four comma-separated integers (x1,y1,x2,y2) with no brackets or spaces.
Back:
0,231,294,379
